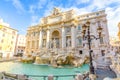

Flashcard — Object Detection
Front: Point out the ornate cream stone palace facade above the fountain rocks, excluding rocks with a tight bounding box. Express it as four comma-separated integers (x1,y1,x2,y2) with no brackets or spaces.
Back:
26,8,109,54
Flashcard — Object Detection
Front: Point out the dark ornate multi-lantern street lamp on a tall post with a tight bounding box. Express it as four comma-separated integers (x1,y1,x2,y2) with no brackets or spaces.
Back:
82,21,103,74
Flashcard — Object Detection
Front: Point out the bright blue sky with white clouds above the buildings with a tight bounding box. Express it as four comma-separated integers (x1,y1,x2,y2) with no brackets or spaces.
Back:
0,0,120,36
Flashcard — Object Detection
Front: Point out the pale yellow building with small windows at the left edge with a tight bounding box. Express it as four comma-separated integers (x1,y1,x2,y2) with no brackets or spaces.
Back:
0,19,18,58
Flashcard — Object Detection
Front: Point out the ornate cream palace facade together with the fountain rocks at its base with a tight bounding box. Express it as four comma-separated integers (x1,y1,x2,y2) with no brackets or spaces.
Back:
22,8,109,66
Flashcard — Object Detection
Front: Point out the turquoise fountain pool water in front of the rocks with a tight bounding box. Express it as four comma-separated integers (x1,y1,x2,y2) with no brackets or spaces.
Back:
0,62,89,80
